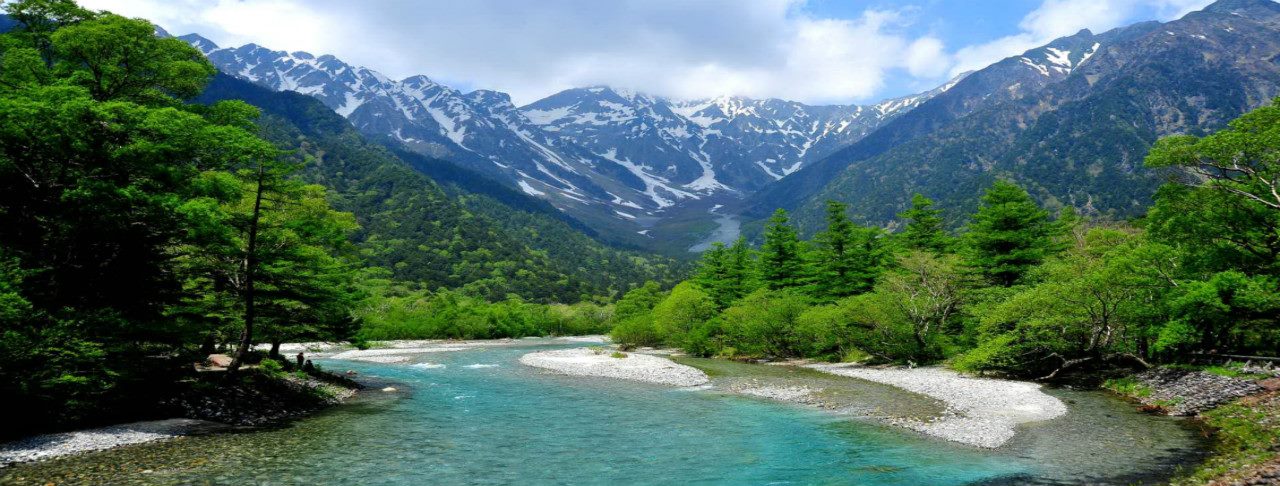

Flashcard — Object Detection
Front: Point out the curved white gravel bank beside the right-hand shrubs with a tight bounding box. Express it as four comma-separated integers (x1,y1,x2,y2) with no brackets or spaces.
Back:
808,365,1066,449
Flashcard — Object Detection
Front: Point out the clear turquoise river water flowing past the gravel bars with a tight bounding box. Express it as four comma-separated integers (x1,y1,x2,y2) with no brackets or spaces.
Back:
0,340,1204,485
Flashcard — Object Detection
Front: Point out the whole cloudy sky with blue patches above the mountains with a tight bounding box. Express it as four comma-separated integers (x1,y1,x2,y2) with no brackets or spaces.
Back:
79,0,1211,105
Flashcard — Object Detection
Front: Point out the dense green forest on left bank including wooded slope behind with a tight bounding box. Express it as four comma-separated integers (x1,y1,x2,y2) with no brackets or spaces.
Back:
0,0,682,434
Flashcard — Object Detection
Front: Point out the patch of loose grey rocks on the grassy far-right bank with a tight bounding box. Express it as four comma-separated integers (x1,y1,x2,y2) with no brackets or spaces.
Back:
1134,368,1266,416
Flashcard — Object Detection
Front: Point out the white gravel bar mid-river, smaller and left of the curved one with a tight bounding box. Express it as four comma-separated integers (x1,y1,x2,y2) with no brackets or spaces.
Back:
520,348,709,386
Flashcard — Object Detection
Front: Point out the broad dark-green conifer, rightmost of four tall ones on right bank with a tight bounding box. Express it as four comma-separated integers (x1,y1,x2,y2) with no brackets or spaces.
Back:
965,180,1053,286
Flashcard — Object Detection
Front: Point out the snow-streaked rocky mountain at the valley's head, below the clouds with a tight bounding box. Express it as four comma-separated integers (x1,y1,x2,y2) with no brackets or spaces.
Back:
180,35,950,225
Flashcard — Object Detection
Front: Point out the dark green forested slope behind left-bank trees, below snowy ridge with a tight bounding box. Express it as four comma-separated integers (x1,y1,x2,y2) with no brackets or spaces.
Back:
200,75,681,302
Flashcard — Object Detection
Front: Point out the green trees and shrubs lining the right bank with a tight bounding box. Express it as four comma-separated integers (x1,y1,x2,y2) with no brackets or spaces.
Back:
612,98,1280,377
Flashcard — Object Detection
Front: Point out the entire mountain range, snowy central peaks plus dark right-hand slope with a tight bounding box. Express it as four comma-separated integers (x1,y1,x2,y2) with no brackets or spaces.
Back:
172,0,1280,248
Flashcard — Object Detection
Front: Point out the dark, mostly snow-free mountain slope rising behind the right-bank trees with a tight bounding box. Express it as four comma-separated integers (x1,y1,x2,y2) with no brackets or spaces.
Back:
755,0,1280,230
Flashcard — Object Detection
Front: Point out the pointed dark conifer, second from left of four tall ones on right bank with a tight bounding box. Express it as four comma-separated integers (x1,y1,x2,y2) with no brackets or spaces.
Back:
813,201,884,299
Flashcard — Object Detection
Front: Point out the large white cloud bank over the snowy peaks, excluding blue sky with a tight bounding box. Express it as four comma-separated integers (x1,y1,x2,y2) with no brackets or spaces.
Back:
72,0,948,102
